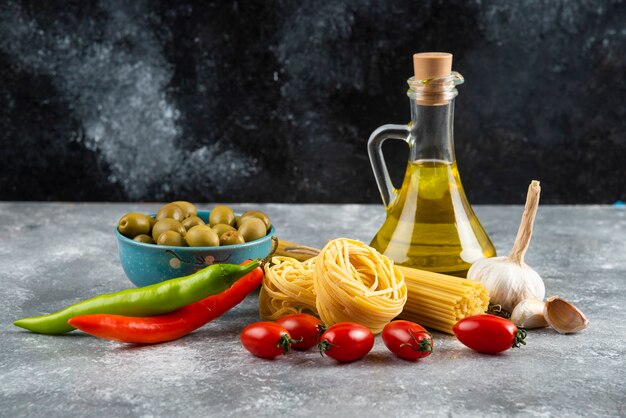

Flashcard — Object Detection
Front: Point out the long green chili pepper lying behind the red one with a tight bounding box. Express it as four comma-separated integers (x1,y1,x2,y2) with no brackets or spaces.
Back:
13,261,259,334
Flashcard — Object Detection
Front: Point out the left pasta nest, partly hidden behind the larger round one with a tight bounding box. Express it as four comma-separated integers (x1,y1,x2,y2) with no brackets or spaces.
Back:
259,257,318,321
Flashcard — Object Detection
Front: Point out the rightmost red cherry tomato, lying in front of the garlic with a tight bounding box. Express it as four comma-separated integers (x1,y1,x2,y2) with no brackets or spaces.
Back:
452,314,526,354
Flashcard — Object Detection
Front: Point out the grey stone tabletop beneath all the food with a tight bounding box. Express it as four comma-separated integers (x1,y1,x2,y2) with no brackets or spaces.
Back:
0,203,626,417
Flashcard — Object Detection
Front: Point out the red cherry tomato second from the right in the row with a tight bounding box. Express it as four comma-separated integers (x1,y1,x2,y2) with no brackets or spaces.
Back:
383,321,433,360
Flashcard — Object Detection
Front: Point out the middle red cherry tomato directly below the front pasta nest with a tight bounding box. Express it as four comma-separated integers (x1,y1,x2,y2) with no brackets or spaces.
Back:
318,322,374,363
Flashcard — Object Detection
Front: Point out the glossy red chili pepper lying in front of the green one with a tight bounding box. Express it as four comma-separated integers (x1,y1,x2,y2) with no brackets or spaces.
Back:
67,263,263,344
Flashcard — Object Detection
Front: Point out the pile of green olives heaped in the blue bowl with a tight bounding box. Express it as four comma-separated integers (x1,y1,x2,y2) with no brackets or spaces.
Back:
117,201,272,247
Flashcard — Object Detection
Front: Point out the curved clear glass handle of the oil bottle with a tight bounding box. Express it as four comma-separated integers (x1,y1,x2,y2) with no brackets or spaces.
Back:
367,125,410,207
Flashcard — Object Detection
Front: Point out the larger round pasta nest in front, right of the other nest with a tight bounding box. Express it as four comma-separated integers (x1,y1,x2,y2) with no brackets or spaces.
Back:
313,238,407,334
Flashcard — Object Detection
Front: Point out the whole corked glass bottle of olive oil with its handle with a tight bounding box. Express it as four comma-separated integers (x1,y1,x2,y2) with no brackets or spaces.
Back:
368,52,496,277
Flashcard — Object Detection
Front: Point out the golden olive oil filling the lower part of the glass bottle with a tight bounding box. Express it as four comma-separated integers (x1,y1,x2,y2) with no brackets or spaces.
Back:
371,160,495,276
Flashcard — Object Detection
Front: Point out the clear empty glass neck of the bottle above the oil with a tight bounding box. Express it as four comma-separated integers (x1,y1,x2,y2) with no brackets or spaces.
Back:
409,99,455,163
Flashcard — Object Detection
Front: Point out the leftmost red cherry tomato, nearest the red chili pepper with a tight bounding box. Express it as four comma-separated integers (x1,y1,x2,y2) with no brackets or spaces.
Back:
240,322,294,359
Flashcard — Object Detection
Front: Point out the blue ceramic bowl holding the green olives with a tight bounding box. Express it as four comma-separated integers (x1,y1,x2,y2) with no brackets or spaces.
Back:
115,210,275,287
